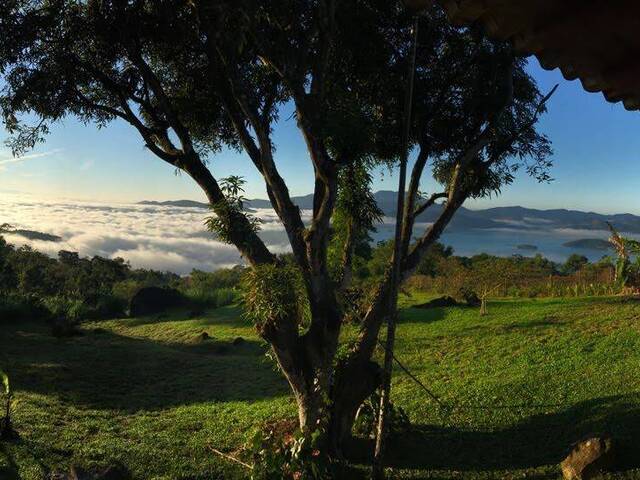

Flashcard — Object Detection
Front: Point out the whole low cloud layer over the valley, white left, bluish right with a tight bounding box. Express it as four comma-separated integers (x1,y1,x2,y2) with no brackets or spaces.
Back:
0,192,620,275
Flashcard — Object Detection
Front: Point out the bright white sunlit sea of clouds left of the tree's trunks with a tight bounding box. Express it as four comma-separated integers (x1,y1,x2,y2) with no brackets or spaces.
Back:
0,194,306,274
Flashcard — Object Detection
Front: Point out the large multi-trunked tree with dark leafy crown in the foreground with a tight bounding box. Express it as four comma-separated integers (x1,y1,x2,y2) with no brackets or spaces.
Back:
0,0,550,453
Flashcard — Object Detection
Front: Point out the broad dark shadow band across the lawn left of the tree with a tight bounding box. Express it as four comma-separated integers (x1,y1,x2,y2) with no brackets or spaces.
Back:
0,325,288,411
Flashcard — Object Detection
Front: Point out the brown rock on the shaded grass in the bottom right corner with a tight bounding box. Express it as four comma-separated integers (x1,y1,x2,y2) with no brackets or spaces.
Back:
560,436,614,480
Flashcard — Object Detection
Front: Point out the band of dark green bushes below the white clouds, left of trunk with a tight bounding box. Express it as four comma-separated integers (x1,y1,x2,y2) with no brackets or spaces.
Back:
0,237,244,323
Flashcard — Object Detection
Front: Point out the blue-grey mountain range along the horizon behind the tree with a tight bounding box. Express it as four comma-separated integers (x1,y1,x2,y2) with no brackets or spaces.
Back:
140,190,640,233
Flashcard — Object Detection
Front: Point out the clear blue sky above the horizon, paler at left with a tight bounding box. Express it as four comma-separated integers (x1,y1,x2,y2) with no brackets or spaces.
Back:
0,60,640,214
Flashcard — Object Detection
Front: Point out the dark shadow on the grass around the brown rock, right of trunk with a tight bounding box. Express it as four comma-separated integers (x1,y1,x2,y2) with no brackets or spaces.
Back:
350,395,640,478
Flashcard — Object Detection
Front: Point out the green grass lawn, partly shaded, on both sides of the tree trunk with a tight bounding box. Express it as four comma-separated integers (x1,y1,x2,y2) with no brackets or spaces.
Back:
0,297,640,480
